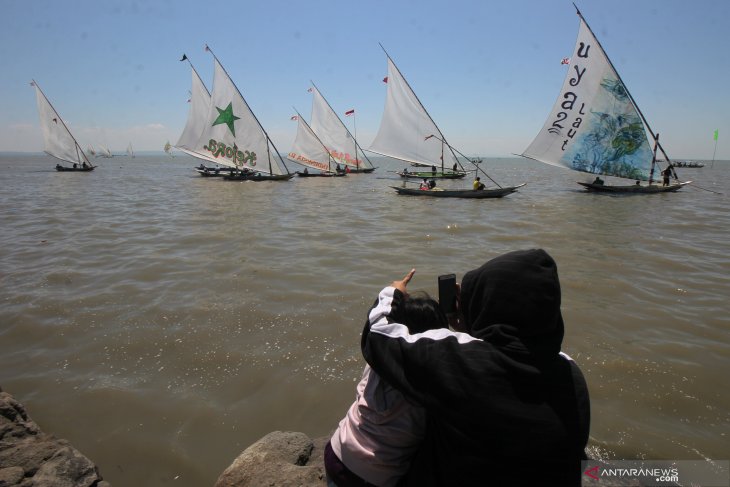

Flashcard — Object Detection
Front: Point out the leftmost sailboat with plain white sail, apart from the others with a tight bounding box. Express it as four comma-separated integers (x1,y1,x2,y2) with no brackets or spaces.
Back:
30,80,95,171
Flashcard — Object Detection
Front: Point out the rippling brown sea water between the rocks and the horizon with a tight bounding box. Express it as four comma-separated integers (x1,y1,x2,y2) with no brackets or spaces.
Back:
0,153,730,487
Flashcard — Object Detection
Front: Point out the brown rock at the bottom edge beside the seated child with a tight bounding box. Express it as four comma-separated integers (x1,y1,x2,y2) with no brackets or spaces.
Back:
210,431,329,487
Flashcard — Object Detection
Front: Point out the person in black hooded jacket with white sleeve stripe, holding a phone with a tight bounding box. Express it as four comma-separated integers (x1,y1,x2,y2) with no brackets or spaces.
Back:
361,249,590,487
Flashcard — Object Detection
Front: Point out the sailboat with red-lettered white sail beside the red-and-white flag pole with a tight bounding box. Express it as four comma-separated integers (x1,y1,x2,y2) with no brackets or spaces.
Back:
310,83,375,173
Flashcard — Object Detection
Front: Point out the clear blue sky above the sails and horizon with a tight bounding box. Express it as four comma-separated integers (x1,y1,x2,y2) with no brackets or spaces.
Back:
0,0,730,160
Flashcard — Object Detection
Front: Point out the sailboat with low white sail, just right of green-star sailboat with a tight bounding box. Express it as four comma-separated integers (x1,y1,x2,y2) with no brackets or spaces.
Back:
287,110,347,177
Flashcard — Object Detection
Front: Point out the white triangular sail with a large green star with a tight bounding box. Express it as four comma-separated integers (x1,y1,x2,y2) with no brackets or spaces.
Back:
191,56,288,175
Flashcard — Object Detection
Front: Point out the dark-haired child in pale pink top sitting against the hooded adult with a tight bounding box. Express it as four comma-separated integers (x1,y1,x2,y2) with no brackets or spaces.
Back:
324,293,449,487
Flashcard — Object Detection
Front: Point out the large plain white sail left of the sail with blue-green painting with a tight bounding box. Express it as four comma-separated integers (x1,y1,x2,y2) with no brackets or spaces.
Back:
368,56,461,170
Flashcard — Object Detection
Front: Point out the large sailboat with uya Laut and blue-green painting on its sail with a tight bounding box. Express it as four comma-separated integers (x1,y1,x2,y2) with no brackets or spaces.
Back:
522,4,691,193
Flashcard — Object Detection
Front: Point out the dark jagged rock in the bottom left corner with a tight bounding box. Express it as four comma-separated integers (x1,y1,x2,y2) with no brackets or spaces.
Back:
0,389,111,487
